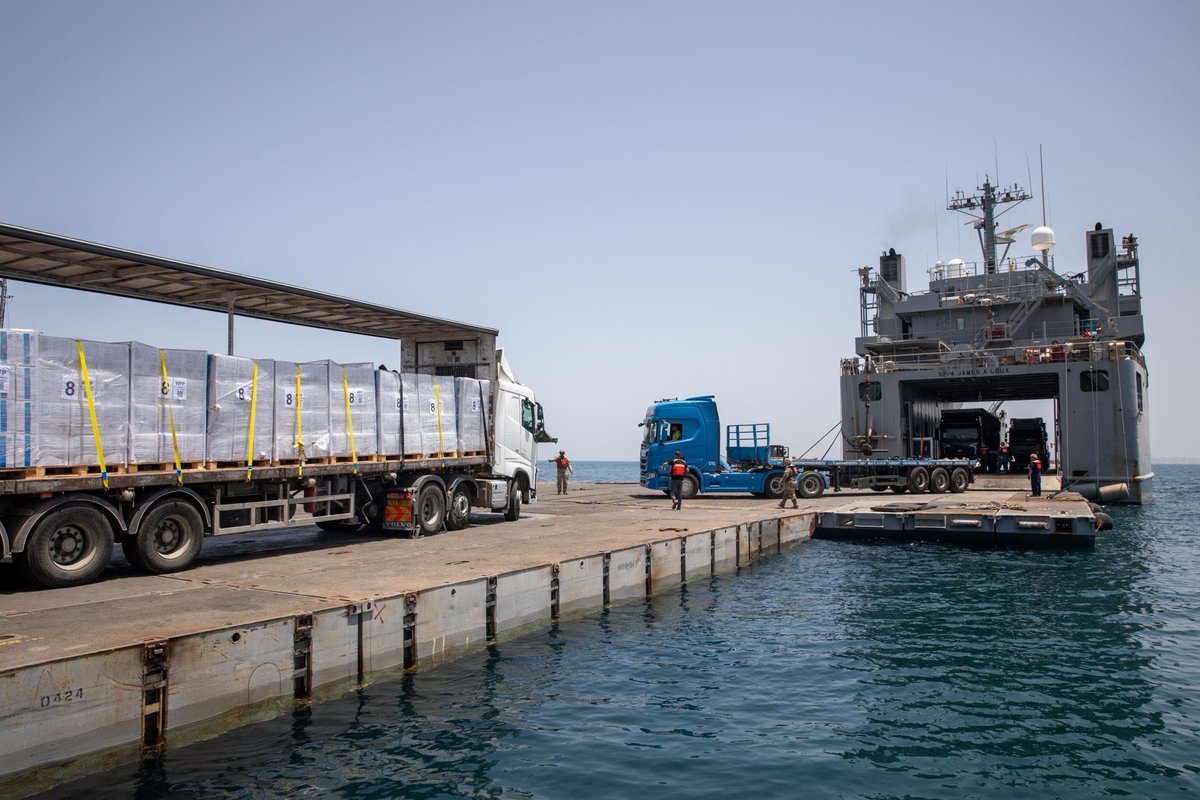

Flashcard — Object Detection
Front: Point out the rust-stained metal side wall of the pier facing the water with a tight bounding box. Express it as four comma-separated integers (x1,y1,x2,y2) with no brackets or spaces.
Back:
0,513,816,796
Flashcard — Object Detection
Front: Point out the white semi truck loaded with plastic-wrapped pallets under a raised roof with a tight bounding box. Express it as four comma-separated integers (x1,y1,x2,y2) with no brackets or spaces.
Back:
0,224,553,588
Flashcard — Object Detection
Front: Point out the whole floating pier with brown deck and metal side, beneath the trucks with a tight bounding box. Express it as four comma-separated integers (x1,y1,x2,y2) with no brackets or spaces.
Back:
0,474,1092,796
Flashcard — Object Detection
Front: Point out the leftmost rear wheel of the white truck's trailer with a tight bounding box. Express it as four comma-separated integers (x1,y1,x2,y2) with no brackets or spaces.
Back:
13,505,113,589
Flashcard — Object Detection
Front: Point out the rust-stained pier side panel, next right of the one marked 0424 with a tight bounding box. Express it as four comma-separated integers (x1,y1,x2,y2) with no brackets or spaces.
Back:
167,616,295,729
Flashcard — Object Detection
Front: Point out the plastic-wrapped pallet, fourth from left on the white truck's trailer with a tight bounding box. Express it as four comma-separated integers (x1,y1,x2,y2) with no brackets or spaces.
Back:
208,354,275,464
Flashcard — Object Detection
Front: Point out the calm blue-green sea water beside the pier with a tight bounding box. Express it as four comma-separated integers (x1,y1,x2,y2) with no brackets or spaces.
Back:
32,464,1200,800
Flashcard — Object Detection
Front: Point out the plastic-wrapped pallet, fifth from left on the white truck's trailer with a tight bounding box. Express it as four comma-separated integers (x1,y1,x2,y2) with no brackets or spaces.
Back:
271,361,332,462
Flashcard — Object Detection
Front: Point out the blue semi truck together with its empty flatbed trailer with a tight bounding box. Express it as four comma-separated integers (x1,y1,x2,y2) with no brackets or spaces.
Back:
640,395,974,498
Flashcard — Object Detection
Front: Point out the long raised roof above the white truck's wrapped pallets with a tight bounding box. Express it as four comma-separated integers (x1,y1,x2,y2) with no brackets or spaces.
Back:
0,223,497,341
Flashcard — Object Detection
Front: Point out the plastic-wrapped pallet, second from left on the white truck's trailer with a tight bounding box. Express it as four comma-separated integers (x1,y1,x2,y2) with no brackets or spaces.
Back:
35,335,130,469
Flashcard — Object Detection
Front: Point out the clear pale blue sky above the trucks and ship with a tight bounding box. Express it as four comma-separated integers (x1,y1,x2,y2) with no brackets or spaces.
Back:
0,0,1200,461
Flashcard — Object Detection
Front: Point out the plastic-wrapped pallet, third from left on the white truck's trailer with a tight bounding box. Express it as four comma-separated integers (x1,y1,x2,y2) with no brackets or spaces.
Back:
130,342,209,464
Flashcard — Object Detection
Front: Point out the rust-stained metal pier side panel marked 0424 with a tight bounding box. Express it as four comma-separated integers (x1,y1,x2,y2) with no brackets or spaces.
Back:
0,644,143,775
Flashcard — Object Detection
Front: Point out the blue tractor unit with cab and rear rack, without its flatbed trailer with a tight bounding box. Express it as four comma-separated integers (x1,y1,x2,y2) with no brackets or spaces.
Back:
641,395,787,498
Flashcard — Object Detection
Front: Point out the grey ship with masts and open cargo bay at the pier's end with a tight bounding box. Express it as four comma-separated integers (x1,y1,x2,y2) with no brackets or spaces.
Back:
841,179,1153,503
